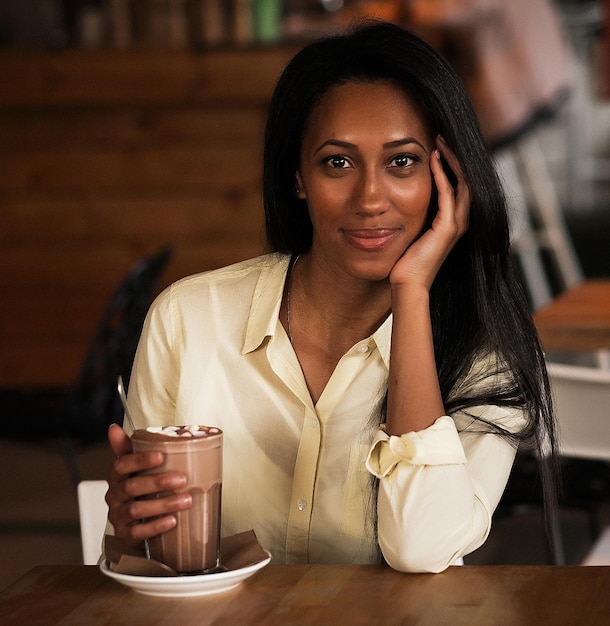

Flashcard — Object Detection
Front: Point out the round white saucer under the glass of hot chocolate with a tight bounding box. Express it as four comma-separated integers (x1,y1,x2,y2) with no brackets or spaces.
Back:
100,550,271,598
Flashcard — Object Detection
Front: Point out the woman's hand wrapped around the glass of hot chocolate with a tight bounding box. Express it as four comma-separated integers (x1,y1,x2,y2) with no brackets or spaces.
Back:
106,424,192,546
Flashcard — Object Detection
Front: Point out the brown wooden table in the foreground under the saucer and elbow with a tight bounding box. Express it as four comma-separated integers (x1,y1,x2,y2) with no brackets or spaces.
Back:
0,564,610,626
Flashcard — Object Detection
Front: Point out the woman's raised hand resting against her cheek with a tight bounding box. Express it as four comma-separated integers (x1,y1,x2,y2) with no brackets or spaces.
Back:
390,136,470,291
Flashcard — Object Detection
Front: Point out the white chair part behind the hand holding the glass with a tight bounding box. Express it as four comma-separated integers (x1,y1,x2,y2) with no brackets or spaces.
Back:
78,480,108,565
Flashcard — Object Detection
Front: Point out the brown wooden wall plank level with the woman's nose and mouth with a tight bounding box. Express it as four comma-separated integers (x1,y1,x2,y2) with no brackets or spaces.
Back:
0,188,263,241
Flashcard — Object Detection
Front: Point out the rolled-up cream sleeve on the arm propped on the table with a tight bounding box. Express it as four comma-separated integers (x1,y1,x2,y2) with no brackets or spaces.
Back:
366,406,525,572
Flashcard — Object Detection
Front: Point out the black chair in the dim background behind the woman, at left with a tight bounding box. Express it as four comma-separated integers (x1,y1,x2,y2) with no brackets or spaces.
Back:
0,246,172,486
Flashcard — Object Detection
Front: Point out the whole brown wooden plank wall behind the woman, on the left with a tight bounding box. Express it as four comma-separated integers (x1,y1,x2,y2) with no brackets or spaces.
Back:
0,48,294,388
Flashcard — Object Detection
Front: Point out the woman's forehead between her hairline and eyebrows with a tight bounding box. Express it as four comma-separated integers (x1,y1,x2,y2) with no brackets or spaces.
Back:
305,81,430,139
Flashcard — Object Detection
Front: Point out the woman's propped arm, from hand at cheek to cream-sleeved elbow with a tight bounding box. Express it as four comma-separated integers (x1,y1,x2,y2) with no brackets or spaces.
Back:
376,138,522,572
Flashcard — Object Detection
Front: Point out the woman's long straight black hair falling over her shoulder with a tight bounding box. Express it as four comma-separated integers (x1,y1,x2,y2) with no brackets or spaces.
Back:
263,22,556,468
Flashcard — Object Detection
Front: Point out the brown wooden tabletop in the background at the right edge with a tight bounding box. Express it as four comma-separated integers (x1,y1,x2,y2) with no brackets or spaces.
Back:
534,279,610,351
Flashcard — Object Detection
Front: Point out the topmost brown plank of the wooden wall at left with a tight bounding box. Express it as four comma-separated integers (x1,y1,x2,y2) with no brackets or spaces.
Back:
0,48,294,107
